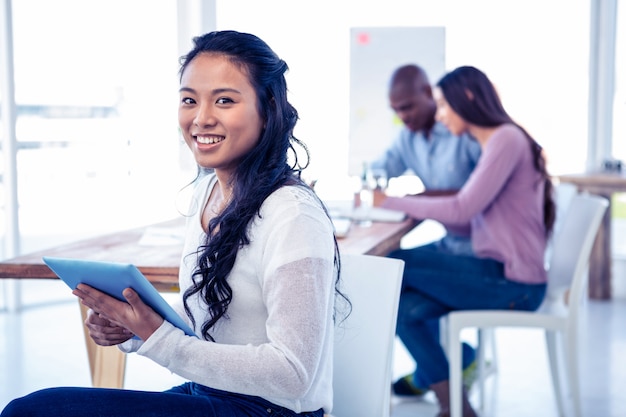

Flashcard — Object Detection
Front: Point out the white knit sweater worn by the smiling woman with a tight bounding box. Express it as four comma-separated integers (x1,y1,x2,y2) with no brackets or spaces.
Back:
121,175,335,412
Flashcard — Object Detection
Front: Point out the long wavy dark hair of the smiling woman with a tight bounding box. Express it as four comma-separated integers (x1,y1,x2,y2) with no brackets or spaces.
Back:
180,31,347,340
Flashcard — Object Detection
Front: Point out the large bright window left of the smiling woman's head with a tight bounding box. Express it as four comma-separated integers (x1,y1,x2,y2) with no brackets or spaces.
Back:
0,0,185,252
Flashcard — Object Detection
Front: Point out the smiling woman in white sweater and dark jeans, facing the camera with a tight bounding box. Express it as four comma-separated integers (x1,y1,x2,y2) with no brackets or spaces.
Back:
1,31,350,417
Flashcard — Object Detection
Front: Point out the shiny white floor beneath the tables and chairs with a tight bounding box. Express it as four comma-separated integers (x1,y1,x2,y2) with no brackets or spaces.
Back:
0,219,626,417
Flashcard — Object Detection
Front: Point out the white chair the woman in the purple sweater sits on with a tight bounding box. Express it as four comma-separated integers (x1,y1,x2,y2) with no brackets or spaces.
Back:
447,194,608,417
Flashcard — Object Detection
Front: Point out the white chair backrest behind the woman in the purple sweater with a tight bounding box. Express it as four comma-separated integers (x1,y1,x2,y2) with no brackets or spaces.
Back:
547,194,608,301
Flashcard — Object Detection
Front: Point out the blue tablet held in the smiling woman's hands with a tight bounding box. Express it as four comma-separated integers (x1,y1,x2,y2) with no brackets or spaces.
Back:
42,256,197,337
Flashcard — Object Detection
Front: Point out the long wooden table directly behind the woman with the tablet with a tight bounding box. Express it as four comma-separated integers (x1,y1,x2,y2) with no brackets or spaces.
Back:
0,214,419,388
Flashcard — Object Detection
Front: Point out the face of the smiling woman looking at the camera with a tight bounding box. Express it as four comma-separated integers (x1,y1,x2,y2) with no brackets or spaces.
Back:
178,53,263,178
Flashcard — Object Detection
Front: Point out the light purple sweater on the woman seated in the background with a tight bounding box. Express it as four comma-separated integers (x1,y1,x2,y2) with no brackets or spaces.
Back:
383,124,546,284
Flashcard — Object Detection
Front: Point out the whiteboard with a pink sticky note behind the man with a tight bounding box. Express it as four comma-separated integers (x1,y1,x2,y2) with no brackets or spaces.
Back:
348,27,445,175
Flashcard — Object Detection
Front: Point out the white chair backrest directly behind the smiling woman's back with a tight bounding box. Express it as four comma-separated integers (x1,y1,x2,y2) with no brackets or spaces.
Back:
332,255,404,417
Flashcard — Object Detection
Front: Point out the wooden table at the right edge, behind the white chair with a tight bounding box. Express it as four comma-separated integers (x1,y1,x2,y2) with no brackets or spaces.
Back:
557,172,626,300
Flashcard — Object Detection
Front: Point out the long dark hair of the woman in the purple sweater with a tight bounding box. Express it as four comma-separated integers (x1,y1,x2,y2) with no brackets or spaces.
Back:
437,66,556,235
